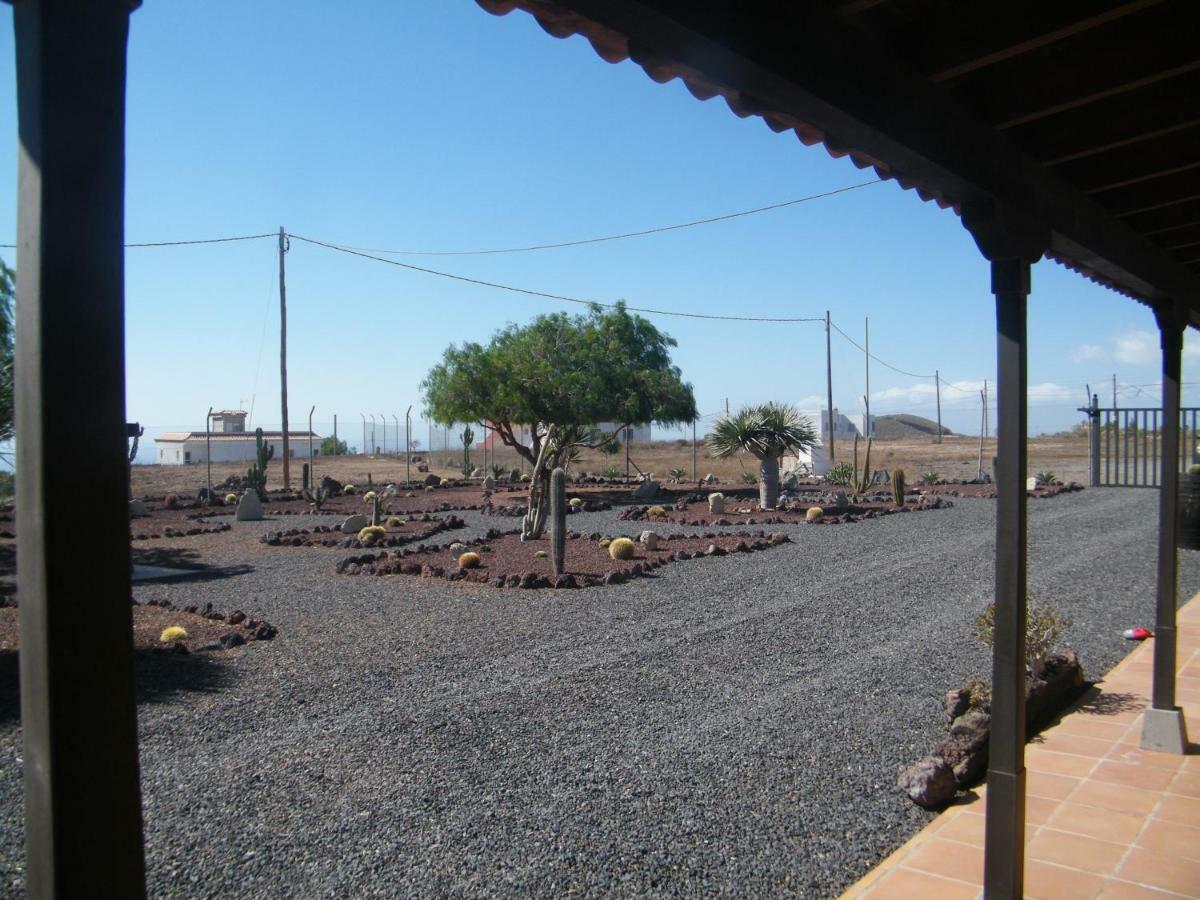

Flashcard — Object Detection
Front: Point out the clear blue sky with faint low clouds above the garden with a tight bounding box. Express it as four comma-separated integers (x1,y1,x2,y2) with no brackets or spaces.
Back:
0,0,1200,460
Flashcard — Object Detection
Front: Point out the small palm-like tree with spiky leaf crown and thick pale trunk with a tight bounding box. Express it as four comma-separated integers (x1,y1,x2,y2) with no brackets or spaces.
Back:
704,403,817,509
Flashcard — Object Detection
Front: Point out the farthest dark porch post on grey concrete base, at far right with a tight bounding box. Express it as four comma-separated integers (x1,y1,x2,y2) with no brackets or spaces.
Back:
1141,311,1188,754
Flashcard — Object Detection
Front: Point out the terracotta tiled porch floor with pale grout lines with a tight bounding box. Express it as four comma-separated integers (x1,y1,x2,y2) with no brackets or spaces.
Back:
842,595,1200,900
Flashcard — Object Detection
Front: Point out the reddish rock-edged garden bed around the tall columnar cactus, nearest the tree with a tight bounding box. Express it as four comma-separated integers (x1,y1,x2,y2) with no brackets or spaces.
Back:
337,532,791,589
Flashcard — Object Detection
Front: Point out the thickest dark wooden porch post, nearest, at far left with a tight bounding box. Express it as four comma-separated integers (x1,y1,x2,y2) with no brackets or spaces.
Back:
13,0,145,898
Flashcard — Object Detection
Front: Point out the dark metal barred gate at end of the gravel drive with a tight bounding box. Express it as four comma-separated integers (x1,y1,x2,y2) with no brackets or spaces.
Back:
1084,406,1200,487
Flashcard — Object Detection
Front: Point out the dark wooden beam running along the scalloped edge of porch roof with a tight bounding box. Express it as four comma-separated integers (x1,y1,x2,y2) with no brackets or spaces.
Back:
506,0,1200,324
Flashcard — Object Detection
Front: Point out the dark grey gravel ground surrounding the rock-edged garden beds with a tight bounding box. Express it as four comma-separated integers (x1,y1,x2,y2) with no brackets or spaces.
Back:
0,490,1200,896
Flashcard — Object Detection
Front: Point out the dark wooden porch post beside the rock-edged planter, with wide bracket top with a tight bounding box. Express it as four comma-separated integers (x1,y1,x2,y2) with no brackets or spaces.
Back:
962,200,1049,898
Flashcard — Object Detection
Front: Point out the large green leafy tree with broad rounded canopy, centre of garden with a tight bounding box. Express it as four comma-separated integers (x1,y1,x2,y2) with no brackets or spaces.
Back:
421,304,696,538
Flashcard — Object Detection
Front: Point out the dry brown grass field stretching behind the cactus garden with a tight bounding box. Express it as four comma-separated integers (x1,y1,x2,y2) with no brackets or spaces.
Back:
132,434,1087,497
